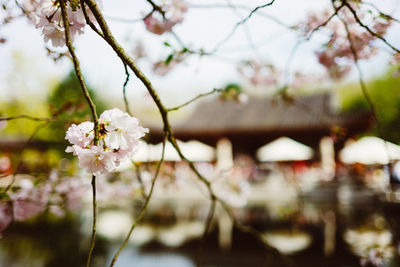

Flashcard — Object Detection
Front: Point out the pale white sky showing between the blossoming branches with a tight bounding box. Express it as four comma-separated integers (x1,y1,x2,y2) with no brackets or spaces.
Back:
0,0,400,109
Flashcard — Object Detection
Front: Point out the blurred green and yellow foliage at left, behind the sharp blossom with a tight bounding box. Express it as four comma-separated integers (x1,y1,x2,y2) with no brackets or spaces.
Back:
0,71,106,142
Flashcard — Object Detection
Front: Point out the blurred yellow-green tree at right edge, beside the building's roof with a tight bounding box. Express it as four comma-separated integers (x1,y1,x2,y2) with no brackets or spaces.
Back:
339,67,400,143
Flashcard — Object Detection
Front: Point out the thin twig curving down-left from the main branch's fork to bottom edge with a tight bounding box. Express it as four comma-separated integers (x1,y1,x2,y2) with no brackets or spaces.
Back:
110,137,167,267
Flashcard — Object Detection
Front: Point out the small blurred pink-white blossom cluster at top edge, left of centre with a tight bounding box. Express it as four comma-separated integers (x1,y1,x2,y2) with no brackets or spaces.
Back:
144,0,188,35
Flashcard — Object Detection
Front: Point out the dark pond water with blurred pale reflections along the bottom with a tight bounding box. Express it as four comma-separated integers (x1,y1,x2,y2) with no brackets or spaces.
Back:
0,185,400,267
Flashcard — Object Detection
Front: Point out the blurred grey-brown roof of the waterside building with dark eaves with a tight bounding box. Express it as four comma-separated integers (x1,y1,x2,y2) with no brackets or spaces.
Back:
149,93,372,158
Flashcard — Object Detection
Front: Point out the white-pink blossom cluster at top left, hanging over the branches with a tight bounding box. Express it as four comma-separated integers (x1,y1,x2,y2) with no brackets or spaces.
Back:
23,0,101,47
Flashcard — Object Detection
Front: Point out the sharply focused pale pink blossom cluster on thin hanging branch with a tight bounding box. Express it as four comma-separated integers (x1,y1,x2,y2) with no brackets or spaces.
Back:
65,108,148,175
